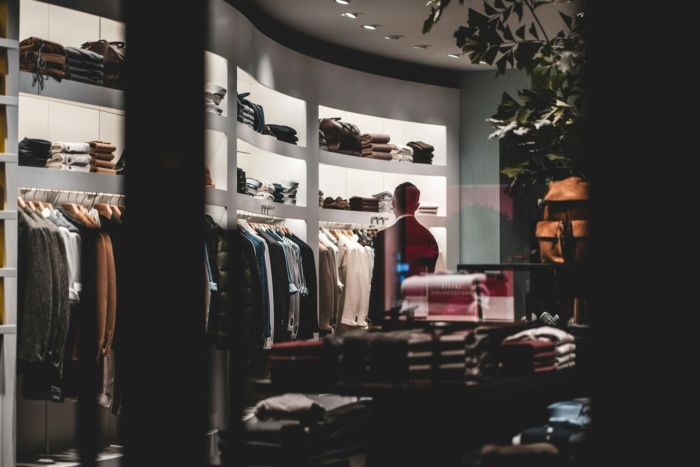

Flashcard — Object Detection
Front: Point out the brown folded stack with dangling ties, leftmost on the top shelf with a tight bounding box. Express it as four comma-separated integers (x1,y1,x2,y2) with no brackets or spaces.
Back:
19,37,66,89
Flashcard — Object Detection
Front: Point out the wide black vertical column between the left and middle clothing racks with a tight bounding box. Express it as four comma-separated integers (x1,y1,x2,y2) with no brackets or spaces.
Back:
120,0,208,466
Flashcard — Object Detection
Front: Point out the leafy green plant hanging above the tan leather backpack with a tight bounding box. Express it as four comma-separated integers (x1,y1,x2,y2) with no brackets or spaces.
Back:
424,0,590,195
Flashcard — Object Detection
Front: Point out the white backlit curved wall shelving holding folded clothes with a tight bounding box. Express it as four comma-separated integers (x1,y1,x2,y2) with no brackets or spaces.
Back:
5,0,459,466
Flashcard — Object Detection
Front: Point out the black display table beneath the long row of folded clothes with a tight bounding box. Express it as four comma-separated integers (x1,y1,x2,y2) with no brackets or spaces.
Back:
254,368,590,467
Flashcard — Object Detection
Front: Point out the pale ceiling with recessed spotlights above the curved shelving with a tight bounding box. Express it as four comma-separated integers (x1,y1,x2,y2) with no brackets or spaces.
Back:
255,0,583,71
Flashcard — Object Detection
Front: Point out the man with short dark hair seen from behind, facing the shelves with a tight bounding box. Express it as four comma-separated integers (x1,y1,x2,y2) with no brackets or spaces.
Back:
368,182,439,323
